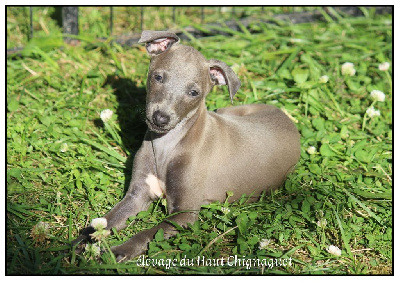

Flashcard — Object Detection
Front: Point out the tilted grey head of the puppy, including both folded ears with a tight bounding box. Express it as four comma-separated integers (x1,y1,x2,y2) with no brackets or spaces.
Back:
139,31,240,133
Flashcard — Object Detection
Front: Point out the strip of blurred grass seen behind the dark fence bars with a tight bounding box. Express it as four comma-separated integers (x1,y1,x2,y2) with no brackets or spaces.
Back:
7,6,315,49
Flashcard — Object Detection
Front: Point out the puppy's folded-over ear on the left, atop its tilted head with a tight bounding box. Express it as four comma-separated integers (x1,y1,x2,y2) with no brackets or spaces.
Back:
139,30,179,56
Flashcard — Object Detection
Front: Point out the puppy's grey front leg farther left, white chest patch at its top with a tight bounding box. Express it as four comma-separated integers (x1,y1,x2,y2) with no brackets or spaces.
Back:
72,138,157,245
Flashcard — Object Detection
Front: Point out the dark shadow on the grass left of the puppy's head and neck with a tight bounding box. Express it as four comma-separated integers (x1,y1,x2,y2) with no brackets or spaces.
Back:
99,75,147,194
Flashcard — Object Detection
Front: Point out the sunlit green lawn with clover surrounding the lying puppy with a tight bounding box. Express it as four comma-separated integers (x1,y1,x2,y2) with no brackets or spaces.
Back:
6,7,393,274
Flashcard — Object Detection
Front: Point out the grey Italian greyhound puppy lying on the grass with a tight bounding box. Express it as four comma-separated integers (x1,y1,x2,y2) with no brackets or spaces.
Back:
73,31,300,261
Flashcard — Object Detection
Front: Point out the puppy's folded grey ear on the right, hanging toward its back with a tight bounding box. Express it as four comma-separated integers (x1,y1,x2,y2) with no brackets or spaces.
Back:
209,59,240,104
